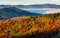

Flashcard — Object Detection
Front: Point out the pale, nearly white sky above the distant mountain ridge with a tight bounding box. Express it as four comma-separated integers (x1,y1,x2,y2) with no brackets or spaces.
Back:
0,0,60,5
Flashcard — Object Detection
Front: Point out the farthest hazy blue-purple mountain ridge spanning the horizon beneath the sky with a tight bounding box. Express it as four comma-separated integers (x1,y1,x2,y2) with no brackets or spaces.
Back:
0,3,60,9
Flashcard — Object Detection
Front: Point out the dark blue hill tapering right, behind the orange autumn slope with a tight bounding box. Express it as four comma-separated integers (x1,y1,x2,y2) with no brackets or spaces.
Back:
0,6,39,18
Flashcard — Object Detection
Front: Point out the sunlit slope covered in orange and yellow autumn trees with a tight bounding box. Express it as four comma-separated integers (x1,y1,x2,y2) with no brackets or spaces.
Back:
0,13,60,36
